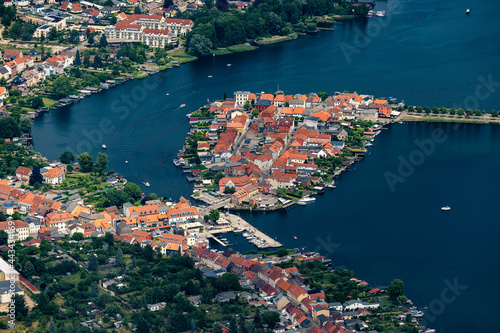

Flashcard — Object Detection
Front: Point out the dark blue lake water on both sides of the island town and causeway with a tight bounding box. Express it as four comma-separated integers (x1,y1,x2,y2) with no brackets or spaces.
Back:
33,0,500,332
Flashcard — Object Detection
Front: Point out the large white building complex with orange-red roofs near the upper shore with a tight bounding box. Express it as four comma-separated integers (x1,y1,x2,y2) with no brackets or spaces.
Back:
104,14,193,47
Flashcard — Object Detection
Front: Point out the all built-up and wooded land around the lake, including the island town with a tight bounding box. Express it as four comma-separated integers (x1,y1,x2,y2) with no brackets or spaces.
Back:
0,0,499,333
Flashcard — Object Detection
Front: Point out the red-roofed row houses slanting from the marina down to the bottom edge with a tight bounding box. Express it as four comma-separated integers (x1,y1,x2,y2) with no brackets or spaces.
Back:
190,243,382,333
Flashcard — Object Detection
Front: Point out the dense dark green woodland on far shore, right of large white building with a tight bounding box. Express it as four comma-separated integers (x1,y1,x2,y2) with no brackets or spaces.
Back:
186,0,368,56
